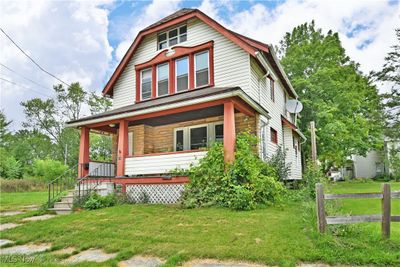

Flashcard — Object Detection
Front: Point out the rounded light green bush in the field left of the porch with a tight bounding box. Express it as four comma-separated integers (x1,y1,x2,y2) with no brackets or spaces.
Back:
32,159,68,182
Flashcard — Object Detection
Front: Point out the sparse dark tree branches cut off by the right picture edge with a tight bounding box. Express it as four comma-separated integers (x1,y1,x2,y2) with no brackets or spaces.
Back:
372,28,400,140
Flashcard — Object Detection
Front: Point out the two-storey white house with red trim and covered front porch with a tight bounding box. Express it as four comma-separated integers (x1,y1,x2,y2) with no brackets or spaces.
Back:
68,9,304,202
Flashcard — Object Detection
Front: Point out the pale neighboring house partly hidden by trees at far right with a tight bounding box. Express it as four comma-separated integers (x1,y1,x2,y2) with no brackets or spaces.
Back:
349,138,400,178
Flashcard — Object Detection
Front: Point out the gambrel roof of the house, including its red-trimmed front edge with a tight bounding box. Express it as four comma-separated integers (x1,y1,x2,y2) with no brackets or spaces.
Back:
103,8,297,98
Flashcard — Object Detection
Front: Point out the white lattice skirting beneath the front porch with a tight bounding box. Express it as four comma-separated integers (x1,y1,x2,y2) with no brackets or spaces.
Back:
126,184,184,204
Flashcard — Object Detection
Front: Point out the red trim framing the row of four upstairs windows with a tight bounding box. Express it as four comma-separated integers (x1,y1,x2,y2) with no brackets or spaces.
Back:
135,41,214,103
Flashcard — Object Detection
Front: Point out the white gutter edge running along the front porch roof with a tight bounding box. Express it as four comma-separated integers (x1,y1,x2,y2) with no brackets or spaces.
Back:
65,90,271,128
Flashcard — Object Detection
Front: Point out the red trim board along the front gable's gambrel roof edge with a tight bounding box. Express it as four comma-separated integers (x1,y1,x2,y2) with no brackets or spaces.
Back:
103,9,256,96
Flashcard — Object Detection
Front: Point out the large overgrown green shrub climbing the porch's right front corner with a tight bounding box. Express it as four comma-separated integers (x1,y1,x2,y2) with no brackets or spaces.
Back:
182,133,285,210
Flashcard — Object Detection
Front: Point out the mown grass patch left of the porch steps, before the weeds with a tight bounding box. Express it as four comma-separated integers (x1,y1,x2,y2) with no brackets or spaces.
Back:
0,191,48,211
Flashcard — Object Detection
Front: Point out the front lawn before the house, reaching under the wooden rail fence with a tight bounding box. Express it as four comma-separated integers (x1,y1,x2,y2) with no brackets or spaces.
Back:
0,182,400,266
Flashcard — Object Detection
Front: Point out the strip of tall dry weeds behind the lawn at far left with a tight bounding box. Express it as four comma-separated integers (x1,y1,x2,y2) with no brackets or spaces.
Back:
0,179,47,192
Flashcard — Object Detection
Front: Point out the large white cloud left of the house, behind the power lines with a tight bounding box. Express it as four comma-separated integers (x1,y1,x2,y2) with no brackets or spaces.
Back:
0,1,112,129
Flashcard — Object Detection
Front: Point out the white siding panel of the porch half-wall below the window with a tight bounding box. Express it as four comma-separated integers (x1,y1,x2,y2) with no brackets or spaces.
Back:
125,151,207,175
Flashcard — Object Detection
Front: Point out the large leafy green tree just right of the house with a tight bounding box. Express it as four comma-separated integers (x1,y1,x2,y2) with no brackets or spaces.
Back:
278,22,382,167
